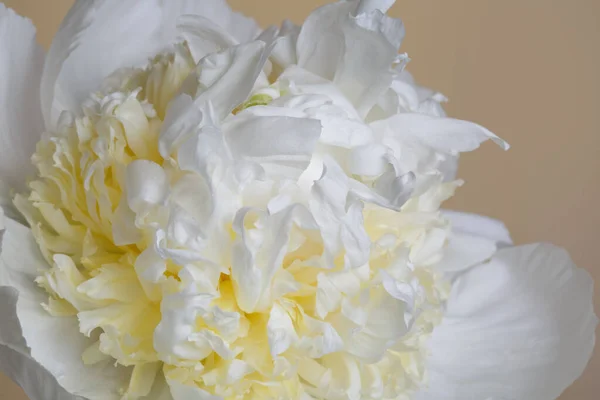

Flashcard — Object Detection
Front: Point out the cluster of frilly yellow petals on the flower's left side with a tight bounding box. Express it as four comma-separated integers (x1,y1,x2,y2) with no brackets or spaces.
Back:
15,47,195,398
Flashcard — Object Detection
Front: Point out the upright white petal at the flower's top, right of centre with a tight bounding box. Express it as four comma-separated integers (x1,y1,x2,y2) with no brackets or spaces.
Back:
297,1,404,115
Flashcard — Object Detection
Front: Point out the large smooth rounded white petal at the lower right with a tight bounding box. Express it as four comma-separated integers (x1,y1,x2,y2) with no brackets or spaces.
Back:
417,244,598,400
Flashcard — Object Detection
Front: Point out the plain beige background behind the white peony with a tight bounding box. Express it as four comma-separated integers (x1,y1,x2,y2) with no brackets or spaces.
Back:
0,0,600,400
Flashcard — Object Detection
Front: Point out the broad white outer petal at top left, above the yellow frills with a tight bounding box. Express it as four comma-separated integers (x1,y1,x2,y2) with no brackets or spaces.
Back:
41,0,257,128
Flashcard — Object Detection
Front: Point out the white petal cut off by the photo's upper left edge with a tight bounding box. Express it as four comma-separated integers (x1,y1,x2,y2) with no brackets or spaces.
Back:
0,4,44,196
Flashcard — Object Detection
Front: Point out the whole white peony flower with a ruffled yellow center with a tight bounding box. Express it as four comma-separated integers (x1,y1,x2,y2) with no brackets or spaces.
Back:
0,0,597,400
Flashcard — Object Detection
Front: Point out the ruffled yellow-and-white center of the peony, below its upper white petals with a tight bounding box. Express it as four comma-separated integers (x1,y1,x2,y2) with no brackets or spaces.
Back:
15,45,448,399
